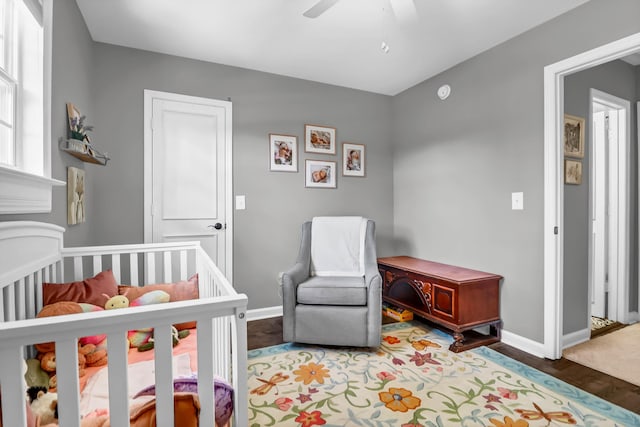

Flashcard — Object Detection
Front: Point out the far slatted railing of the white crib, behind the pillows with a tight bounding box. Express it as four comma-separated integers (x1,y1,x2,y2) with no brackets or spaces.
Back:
0,242,236,322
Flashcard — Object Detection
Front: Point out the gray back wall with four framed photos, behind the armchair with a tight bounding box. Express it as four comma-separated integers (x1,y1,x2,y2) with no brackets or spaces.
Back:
91,43,393,309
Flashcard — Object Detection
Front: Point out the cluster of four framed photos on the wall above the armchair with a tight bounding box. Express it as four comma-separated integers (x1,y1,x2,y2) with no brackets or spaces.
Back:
269,124,366,188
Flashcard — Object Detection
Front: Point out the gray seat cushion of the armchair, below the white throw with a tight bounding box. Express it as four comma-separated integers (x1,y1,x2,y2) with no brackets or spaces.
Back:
297,276,367,306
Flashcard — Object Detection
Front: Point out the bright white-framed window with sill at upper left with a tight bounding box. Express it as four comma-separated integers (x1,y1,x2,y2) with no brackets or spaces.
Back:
0,0,63,213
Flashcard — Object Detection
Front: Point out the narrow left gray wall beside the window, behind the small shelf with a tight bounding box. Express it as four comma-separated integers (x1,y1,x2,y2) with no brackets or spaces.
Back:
0,0,98,246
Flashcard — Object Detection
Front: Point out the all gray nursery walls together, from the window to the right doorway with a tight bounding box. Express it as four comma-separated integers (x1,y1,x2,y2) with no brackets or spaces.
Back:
1,0,640,342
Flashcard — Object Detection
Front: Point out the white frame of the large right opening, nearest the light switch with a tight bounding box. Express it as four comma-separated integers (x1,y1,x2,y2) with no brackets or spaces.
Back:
543,33,640,359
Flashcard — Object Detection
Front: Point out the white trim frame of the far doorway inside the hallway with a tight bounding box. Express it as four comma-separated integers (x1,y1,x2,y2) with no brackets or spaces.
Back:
585,88,631,329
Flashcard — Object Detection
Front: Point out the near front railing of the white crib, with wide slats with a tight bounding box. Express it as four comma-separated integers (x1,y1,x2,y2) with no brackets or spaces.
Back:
0,295,247,427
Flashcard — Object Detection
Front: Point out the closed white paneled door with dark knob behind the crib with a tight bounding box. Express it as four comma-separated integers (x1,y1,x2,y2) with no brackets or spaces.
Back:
144,90,232,280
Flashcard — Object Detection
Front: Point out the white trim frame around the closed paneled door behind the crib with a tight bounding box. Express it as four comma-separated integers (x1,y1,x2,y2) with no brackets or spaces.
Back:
143,89,234,284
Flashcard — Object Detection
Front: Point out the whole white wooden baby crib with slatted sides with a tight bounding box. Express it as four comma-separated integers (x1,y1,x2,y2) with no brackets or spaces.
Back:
0,221,247,427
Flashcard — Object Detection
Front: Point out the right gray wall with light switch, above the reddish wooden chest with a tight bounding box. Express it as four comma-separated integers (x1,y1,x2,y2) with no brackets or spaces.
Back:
393,0,640,342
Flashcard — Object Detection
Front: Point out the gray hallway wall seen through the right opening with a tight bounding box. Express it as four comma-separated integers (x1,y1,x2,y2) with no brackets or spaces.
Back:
564,60,638,334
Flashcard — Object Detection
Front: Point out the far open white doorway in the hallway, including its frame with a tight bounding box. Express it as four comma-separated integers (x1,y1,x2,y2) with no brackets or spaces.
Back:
588,88,631,337
